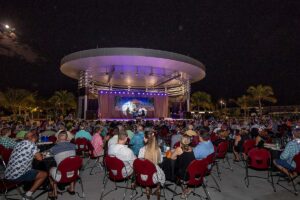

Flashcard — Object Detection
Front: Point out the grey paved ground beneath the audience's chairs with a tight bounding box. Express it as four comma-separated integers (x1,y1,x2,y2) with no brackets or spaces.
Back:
1,155,300,200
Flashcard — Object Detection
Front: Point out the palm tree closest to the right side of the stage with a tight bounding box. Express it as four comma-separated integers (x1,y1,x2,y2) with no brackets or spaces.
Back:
191,91,213,111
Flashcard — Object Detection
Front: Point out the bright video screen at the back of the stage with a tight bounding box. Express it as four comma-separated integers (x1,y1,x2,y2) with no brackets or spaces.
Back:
115,96,154,117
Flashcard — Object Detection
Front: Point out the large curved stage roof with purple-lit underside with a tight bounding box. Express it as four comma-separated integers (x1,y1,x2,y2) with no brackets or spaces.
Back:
60,48,205,92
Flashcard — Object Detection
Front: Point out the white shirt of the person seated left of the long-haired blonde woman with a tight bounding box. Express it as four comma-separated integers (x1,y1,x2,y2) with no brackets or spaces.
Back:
108,144,136,178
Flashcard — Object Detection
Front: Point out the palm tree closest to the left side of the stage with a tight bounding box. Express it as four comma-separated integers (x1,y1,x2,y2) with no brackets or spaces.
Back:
49,90,76,115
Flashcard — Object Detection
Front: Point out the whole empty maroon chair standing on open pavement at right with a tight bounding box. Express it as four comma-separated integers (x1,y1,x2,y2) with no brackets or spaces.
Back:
244,148,276,192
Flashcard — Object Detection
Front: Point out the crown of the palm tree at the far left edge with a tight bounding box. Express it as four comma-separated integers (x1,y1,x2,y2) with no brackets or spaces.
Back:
0,88,37,116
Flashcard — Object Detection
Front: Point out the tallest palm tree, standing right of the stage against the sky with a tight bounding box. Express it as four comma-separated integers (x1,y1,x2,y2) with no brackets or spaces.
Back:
247,85,277,116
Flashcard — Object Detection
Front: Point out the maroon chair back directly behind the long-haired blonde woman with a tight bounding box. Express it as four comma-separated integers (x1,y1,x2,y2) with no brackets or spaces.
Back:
133,158,157,187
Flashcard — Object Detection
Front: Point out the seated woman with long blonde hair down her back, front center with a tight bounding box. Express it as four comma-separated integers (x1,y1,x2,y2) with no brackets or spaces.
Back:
138,130,166,185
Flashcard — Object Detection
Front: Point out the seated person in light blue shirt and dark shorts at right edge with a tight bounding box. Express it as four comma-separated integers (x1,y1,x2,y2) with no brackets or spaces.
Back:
273,128,300,178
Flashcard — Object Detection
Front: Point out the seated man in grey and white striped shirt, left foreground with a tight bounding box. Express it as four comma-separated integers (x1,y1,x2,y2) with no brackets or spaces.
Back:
49,131,76,198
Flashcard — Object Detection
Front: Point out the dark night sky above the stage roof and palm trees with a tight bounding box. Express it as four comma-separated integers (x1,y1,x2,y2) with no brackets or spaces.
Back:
0,0,300,105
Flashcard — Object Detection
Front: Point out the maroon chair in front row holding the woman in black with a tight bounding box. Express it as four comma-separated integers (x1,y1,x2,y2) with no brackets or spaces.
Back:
172,159,211,200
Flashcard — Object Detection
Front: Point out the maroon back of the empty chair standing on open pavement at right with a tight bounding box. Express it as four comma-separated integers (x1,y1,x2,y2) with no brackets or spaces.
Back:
247,148,271,170
